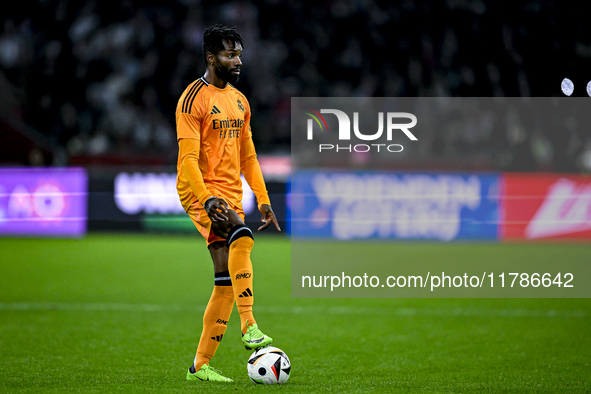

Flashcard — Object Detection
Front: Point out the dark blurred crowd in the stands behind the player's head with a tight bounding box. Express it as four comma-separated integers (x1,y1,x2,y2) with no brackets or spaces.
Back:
0,0,591,171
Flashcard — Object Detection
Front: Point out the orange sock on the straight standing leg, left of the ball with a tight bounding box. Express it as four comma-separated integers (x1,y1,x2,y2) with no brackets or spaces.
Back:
194,271,234,371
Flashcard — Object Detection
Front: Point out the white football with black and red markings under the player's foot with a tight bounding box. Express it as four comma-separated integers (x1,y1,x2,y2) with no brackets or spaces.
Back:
246,346,291,384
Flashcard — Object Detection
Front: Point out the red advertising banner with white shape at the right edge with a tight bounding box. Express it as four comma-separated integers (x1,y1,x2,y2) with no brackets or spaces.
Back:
499,173,591,240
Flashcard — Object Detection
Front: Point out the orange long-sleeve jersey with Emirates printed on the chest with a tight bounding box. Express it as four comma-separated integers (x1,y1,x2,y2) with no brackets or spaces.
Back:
176,78,270,211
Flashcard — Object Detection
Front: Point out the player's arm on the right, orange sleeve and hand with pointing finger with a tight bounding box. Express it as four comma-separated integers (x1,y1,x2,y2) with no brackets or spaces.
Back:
240,104,281,231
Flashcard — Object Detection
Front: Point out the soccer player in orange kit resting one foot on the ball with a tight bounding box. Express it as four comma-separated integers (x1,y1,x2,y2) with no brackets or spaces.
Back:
176,25,281,382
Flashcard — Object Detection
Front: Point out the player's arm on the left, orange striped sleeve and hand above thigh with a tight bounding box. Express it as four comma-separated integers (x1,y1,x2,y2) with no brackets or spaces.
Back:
177,113,228,222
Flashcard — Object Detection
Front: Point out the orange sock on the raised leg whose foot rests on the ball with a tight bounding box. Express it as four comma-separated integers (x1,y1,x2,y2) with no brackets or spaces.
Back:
228,231,256,334
